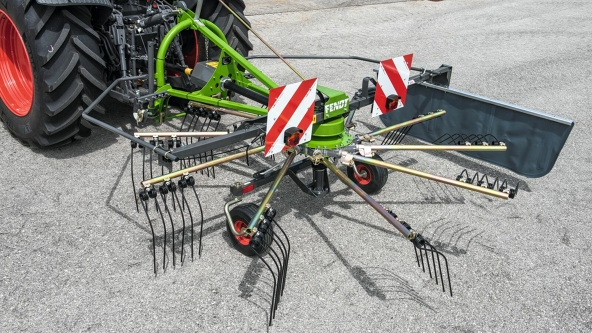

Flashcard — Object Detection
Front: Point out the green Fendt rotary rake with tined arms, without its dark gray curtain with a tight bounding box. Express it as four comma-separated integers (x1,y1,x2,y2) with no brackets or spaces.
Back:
78,1,572,325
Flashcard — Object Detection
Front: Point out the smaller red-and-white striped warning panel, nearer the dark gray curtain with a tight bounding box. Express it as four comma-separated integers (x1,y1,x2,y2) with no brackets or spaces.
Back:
372,54,413,117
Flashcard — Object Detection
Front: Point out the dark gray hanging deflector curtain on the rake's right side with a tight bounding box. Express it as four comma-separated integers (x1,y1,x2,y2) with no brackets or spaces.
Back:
381,83,574,178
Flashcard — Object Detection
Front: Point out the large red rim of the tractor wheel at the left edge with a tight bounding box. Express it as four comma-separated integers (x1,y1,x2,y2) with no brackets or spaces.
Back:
0,10,33,117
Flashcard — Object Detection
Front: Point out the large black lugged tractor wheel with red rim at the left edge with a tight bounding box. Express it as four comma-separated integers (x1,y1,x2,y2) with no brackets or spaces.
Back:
0,0,106,147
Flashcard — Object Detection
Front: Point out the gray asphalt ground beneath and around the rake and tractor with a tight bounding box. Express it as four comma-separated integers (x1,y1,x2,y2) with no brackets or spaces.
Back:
0,0,592,332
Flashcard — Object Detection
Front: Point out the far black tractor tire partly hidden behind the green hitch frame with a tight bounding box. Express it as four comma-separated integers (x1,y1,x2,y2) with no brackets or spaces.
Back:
199,0,253,61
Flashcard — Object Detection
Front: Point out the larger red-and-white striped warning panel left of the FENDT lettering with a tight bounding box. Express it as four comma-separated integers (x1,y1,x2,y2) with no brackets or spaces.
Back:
265,79,317,156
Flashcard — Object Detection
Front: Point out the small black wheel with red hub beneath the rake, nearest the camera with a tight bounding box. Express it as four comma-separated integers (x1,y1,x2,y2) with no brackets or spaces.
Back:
226,203,273,257
